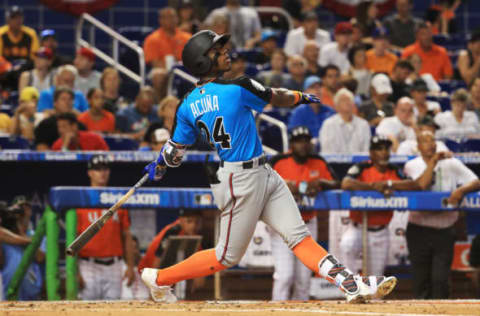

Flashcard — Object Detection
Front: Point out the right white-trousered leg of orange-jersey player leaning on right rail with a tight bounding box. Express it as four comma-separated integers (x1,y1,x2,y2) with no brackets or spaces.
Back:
368,228,390,275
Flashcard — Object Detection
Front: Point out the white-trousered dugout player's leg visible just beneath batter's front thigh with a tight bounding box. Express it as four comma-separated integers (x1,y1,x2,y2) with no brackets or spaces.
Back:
270,231,295,301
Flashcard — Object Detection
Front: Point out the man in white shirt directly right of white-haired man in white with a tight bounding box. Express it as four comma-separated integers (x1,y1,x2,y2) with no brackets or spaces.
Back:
376,97,416,152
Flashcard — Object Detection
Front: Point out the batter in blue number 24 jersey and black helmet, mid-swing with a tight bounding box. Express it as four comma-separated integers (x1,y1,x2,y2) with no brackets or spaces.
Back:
142,30,396,302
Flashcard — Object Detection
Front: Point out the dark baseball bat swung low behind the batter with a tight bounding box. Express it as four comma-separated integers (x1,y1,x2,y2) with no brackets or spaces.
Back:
66,173,148,256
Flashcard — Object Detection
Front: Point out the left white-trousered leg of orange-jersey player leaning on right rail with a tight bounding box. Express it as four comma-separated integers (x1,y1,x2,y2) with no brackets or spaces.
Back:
340,223,362,273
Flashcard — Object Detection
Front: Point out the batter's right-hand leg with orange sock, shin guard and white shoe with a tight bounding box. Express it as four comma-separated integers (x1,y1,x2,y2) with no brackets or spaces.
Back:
261,168,396,302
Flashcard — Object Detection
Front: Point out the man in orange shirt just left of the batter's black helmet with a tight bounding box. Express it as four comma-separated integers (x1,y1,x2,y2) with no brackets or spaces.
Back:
143,7,192,98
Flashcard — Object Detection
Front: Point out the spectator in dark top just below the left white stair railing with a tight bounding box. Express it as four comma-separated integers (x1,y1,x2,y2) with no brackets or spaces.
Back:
100,67,126,114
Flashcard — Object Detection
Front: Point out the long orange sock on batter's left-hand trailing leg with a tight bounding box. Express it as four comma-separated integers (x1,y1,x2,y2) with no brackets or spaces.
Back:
157,249,227,285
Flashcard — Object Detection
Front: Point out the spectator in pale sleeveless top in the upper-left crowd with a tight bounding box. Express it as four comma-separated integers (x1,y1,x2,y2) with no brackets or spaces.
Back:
18,46,55,91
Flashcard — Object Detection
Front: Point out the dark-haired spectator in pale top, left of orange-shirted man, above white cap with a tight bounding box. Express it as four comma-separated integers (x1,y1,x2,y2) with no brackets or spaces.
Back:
348,44,372,97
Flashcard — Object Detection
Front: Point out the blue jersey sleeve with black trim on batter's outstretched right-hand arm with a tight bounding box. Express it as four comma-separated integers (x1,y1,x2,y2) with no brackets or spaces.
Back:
235,77,272,112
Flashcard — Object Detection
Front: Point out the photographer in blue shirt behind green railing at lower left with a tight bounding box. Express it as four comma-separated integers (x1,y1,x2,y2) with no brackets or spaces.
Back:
0,196,45,300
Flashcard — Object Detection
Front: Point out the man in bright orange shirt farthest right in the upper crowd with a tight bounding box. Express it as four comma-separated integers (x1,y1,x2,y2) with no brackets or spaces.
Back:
402,23,453,81
